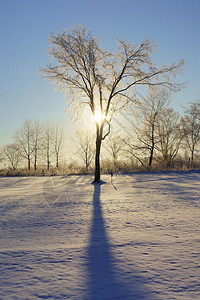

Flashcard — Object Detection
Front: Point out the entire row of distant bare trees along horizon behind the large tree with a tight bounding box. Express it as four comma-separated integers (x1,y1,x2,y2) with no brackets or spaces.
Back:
1,91,200,173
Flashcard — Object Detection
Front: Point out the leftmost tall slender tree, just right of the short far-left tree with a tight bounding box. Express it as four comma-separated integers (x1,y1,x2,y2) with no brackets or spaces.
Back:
15,120,33,170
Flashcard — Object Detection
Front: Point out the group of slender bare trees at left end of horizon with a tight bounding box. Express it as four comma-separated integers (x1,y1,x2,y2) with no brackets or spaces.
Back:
1,120,65,170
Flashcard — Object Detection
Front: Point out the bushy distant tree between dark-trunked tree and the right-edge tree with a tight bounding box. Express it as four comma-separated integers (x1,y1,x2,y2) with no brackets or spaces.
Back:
158,108,183,167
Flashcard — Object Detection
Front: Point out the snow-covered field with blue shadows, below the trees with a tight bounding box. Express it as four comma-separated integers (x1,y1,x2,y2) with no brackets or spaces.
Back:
0,172,200,300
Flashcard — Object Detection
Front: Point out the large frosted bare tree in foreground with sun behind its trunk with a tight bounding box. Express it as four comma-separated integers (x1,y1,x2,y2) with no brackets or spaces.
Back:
41,27,184,182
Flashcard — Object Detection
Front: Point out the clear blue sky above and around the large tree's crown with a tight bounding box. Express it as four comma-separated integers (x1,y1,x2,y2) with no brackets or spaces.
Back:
0,0,200,146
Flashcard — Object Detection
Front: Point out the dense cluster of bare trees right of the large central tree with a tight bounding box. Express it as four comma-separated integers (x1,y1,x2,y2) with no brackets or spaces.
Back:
110,91,200,169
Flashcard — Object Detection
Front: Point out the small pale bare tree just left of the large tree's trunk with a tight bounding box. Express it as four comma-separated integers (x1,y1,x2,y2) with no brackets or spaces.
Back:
75,130,95,173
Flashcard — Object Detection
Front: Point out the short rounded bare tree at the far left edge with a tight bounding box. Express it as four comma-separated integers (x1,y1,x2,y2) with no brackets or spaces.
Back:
3,144,21,170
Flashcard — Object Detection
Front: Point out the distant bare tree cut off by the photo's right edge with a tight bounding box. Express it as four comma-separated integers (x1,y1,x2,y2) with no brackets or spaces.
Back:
181,103,200,164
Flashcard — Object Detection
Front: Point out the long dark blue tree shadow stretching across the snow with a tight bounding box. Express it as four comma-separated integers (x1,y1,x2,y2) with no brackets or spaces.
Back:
86,184,156,300
